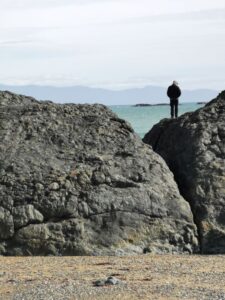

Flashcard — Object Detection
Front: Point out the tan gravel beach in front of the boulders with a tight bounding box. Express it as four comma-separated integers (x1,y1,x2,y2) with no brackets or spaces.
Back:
0,254,225,300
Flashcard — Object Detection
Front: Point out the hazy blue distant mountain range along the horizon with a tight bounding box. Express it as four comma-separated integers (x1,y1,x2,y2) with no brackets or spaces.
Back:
0,84,218,105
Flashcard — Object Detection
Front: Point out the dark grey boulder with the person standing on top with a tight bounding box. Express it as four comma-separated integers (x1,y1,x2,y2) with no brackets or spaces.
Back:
143,91,225,253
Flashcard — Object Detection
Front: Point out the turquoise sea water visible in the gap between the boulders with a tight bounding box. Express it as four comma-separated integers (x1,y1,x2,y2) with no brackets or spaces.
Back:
110,103,203,137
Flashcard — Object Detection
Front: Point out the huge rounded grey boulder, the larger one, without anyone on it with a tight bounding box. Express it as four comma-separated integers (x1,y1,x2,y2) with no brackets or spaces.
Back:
0,92,198,255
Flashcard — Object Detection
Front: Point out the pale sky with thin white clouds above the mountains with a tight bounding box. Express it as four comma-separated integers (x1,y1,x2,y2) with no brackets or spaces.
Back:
0,0,225,91
